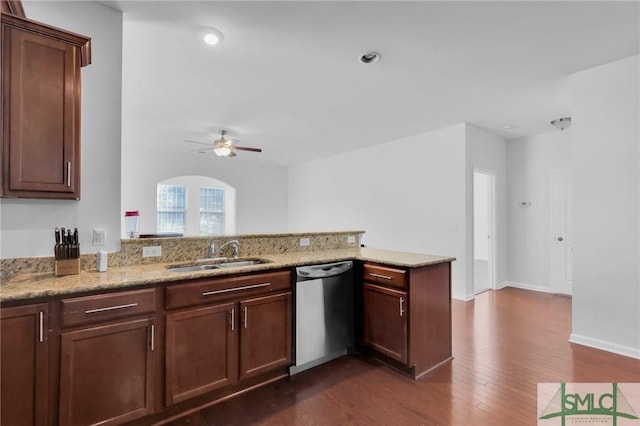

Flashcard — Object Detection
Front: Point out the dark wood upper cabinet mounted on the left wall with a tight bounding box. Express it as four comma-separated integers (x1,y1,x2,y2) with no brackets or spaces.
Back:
0,13,91,200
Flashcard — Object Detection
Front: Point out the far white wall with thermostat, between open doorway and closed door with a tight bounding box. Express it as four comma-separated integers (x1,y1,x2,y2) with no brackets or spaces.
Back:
507,128,572,291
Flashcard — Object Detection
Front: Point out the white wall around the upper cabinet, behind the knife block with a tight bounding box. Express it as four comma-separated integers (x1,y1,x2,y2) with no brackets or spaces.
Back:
0,1,122,259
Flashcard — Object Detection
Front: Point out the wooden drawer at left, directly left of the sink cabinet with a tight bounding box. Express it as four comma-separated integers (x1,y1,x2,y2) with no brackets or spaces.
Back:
60,289,156,327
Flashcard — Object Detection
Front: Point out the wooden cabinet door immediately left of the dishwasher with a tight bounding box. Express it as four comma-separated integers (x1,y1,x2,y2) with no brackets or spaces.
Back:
240,292,291,380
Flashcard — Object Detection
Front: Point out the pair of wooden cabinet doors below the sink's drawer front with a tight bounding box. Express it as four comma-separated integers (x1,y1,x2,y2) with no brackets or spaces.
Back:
165,292,291,405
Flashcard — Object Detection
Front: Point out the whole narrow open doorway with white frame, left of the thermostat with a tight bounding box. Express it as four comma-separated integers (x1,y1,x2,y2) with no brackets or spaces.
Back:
473,170,495,294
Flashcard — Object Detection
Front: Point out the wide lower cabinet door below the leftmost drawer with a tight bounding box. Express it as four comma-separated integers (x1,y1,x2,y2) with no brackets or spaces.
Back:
60,319,156,425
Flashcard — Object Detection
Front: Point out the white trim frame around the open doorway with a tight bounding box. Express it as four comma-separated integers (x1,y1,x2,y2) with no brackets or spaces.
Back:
471,167,496,295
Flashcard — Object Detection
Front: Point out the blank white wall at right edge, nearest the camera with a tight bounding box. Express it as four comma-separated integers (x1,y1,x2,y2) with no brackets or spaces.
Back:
571,56,640,358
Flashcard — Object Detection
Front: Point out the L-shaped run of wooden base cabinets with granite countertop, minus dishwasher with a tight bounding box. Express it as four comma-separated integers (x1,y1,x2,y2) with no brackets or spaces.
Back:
0,231,455,425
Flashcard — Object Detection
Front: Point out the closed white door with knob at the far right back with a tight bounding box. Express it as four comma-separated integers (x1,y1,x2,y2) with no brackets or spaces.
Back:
549,169,573,295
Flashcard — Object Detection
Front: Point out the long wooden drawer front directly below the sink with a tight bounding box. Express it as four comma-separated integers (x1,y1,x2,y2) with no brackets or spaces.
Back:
166,271,291,309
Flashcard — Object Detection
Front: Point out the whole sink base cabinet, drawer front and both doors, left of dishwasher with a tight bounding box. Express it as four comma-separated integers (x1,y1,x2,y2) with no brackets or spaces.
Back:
165,270,292,406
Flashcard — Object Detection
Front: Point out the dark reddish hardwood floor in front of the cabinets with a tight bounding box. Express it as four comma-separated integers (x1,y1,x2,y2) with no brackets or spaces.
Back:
166,288,640,426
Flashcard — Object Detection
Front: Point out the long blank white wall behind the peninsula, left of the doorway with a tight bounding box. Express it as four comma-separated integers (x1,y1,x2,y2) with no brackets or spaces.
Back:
289,124,473,298
